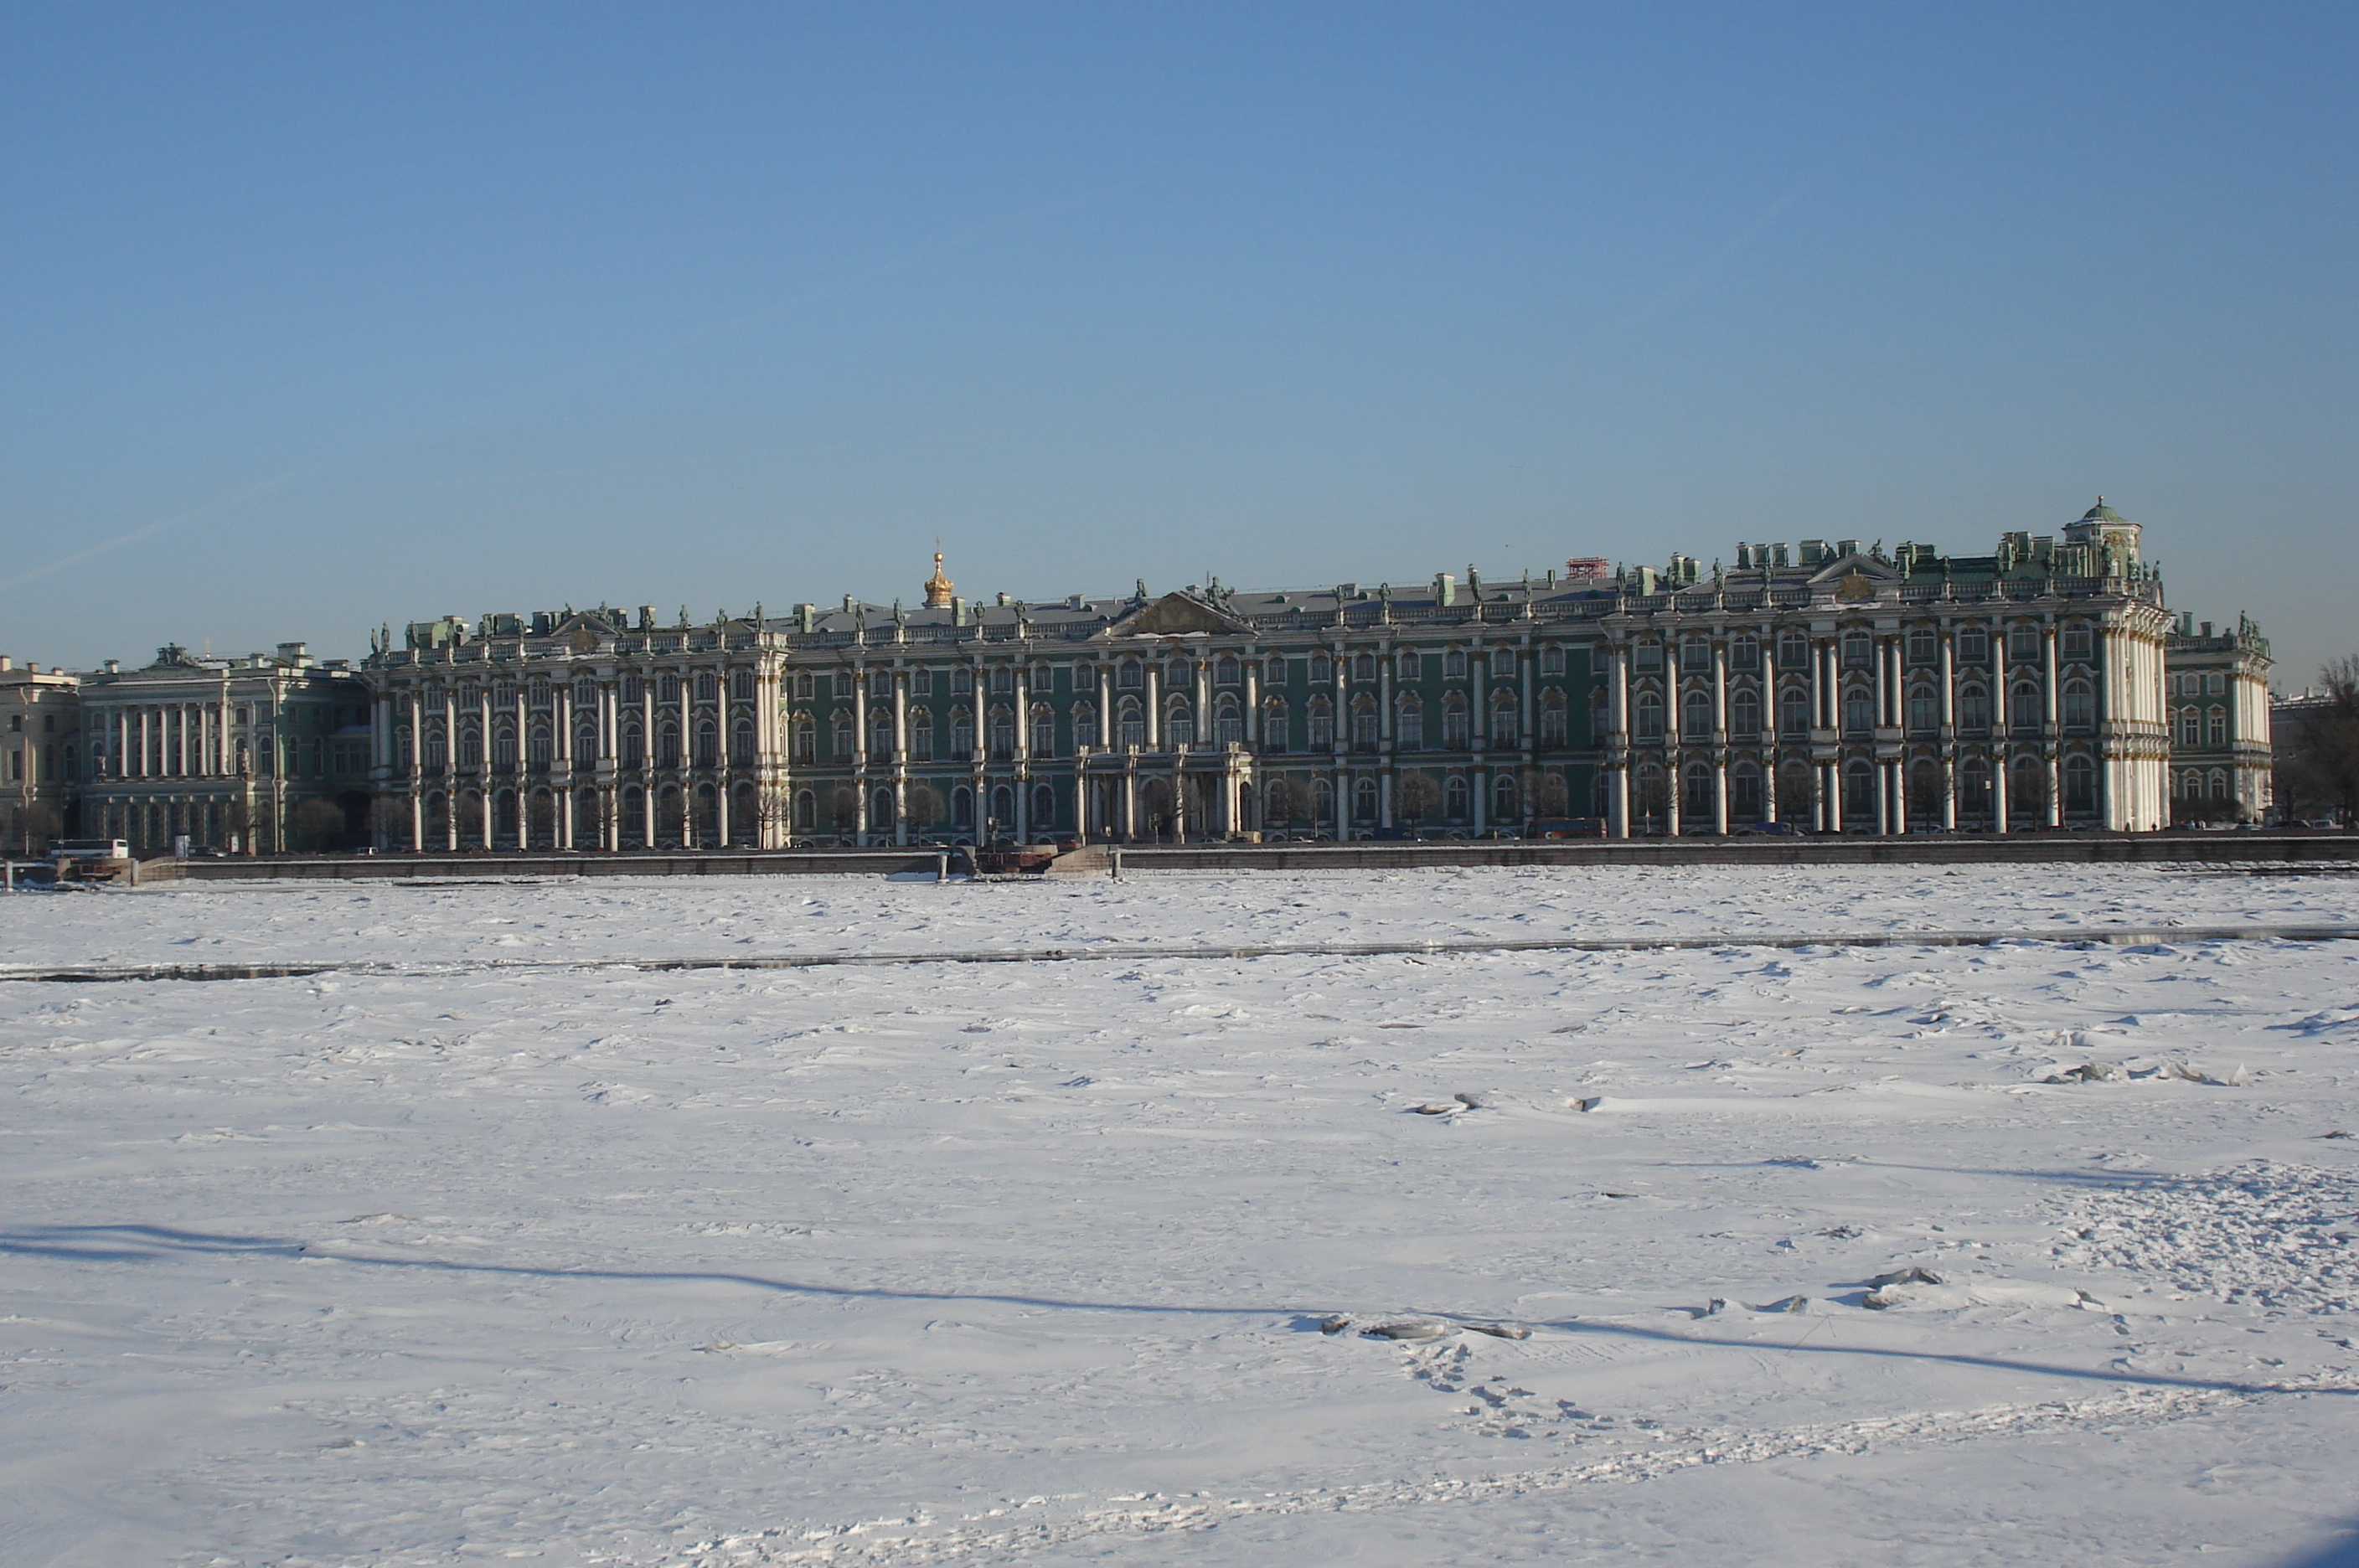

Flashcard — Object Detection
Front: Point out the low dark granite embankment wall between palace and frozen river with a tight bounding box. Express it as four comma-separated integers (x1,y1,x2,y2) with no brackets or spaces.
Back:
139,833,2359,885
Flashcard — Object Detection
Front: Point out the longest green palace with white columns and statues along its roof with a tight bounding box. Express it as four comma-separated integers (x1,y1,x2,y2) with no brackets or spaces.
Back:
368,503,2175,851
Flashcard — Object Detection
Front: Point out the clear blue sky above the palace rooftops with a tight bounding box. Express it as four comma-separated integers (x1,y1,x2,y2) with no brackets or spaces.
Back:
0,3,2359,686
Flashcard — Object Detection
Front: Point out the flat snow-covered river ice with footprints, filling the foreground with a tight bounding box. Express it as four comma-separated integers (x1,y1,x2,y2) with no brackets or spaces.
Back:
0,868,2359,1568
